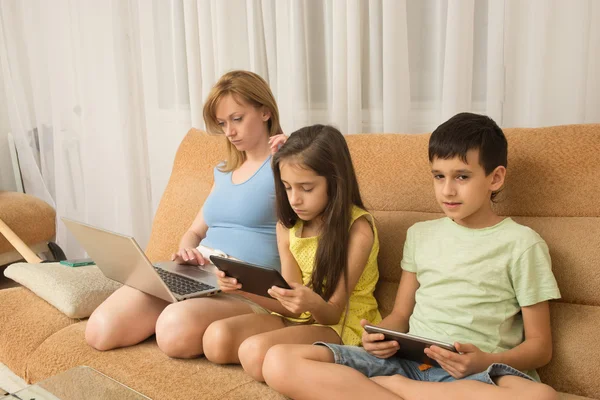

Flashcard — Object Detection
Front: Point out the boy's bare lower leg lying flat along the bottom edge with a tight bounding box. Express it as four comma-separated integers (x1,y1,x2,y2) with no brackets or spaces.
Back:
373,375,558,400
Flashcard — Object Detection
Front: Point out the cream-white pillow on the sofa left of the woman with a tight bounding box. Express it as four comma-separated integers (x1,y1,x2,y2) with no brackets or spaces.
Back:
4,263,121,318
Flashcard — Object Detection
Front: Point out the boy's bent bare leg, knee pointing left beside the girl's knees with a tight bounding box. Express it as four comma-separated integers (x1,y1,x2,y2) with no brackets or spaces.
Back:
263,345,402,400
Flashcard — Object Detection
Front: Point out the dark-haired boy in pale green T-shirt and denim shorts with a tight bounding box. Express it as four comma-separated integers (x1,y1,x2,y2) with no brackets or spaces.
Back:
263,113,560,400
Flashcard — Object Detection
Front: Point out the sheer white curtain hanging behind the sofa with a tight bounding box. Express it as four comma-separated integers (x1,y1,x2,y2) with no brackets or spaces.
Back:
0,0,600,256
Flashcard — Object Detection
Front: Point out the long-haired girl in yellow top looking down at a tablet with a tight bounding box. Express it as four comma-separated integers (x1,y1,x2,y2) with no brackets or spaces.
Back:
204,125,381,381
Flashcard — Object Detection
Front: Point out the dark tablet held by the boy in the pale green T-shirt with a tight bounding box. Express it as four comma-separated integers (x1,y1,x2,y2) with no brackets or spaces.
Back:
365,325,458,367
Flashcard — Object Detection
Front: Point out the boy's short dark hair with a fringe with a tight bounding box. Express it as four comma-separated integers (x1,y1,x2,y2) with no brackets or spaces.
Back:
429,112,508,200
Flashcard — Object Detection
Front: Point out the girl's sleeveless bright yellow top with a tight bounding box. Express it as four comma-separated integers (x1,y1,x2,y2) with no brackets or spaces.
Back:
285,206,381,346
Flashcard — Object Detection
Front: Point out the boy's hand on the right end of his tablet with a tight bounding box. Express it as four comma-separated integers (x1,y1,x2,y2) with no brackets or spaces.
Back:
425,342,492,379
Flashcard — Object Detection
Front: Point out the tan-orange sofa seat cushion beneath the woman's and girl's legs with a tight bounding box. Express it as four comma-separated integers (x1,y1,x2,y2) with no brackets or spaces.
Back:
26,321,285,400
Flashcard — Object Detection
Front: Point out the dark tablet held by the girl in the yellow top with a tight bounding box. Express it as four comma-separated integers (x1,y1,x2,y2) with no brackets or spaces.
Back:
210,256,291,298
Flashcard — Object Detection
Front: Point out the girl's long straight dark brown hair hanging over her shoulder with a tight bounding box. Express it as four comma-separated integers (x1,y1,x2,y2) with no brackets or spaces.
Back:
273,125,365,301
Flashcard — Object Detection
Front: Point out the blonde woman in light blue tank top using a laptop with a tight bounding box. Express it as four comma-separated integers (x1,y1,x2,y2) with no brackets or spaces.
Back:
85,71,284,358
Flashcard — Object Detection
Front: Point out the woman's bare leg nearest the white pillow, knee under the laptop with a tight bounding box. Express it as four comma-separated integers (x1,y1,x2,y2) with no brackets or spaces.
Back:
85,286,169,350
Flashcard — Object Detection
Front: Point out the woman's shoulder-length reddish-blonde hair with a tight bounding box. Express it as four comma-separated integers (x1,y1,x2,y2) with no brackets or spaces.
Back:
203,70,282,172
